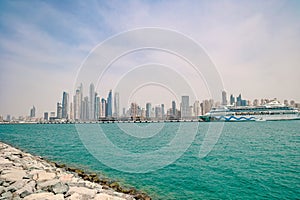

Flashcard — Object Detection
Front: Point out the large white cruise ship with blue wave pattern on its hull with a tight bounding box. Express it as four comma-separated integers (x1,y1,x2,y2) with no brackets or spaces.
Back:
200,101,300,122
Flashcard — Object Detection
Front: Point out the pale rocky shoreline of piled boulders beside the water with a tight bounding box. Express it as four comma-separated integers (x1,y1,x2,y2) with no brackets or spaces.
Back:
0,142,151,200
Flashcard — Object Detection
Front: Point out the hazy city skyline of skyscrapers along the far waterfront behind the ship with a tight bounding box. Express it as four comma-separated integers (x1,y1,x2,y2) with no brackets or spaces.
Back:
0,86,300,123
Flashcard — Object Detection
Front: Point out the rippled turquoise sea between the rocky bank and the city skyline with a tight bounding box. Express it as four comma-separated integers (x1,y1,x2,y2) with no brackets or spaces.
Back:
0,120,300,200
